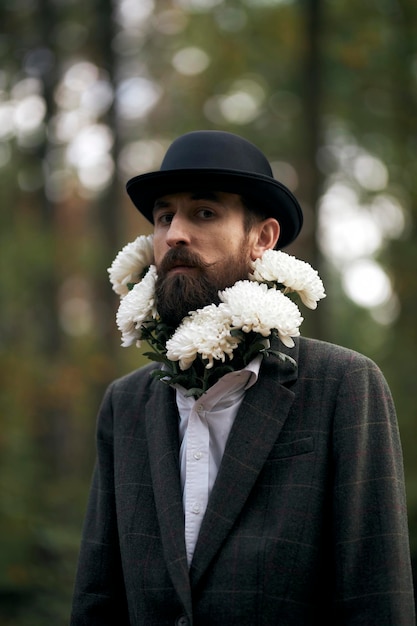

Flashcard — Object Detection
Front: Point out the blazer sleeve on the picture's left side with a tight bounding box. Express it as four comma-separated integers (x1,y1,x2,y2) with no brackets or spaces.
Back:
70,380,129,626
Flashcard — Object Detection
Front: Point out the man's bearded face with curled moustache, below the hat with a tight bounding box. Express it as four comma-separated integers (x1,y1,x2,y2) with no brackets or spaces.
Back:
154,192,252,327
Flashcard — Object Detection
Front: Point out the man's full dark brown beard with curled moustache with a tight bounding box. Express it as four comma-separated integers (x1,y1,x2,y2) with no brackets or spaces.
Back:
155,245,250,328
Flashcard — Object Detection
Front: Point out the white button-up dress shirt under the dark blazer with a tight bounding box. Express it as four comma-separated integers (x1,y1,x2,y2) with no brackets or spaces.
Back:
176,355,262,564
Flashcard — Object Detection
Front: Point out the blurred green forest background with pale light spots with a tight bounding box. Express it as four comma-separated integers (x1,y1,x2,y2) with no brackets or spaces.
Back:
0,0,417,626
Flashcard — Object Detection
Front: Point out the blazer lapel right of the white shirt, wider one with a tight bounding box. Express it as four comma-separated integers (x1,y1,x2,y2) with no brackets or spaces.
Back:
190,345,298,588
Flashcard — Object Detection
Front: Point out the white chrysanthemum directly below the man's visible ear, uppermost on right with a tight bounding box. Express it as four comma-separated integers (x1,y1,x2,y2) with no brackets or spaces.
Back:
249,250,326,309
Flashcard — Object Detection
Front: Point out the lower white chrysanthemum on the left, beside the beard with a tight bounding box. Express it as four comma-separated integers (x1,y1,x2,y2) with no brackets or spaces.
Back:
116,265,157,348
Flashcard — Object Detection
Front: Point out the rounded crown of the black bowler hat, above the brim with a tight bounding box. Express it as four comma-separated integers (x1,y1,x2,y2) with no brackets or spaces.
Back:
160,130,273,178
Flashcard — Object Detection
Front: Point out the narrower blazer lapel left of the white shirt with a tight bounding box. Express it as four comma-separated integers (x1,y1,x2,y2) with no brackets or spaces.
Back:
145,381,192,616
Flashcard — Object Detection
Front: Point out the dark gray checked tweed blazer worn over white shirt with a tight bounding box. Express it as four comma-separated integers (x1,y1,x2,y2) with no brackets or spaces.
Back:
71,338,415,626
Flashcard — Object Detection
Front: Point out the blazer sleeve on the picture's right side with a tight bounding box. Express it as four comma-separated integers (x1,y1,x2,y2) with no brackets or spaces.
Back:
333,356,415,626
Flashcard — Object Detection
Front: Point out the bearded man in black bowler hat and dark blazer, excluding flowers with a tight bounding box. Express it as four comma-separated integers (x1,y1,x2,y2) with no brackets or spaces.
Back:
71,131,415,626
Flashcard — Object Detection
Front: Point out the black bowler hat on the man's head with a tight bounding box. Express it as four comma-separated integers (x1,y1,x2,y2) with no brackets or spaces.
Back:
126,130,303,248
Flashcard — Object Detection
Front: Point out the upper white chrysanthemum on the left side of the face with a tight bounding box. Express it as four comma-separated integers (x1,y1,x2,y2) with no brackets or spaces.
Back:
107,235,154,297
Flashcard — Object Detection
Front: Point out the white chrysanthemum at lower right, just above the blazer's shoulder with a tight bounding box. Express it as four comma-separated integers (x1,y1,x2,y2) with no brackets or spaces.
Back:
219,280,303,348
